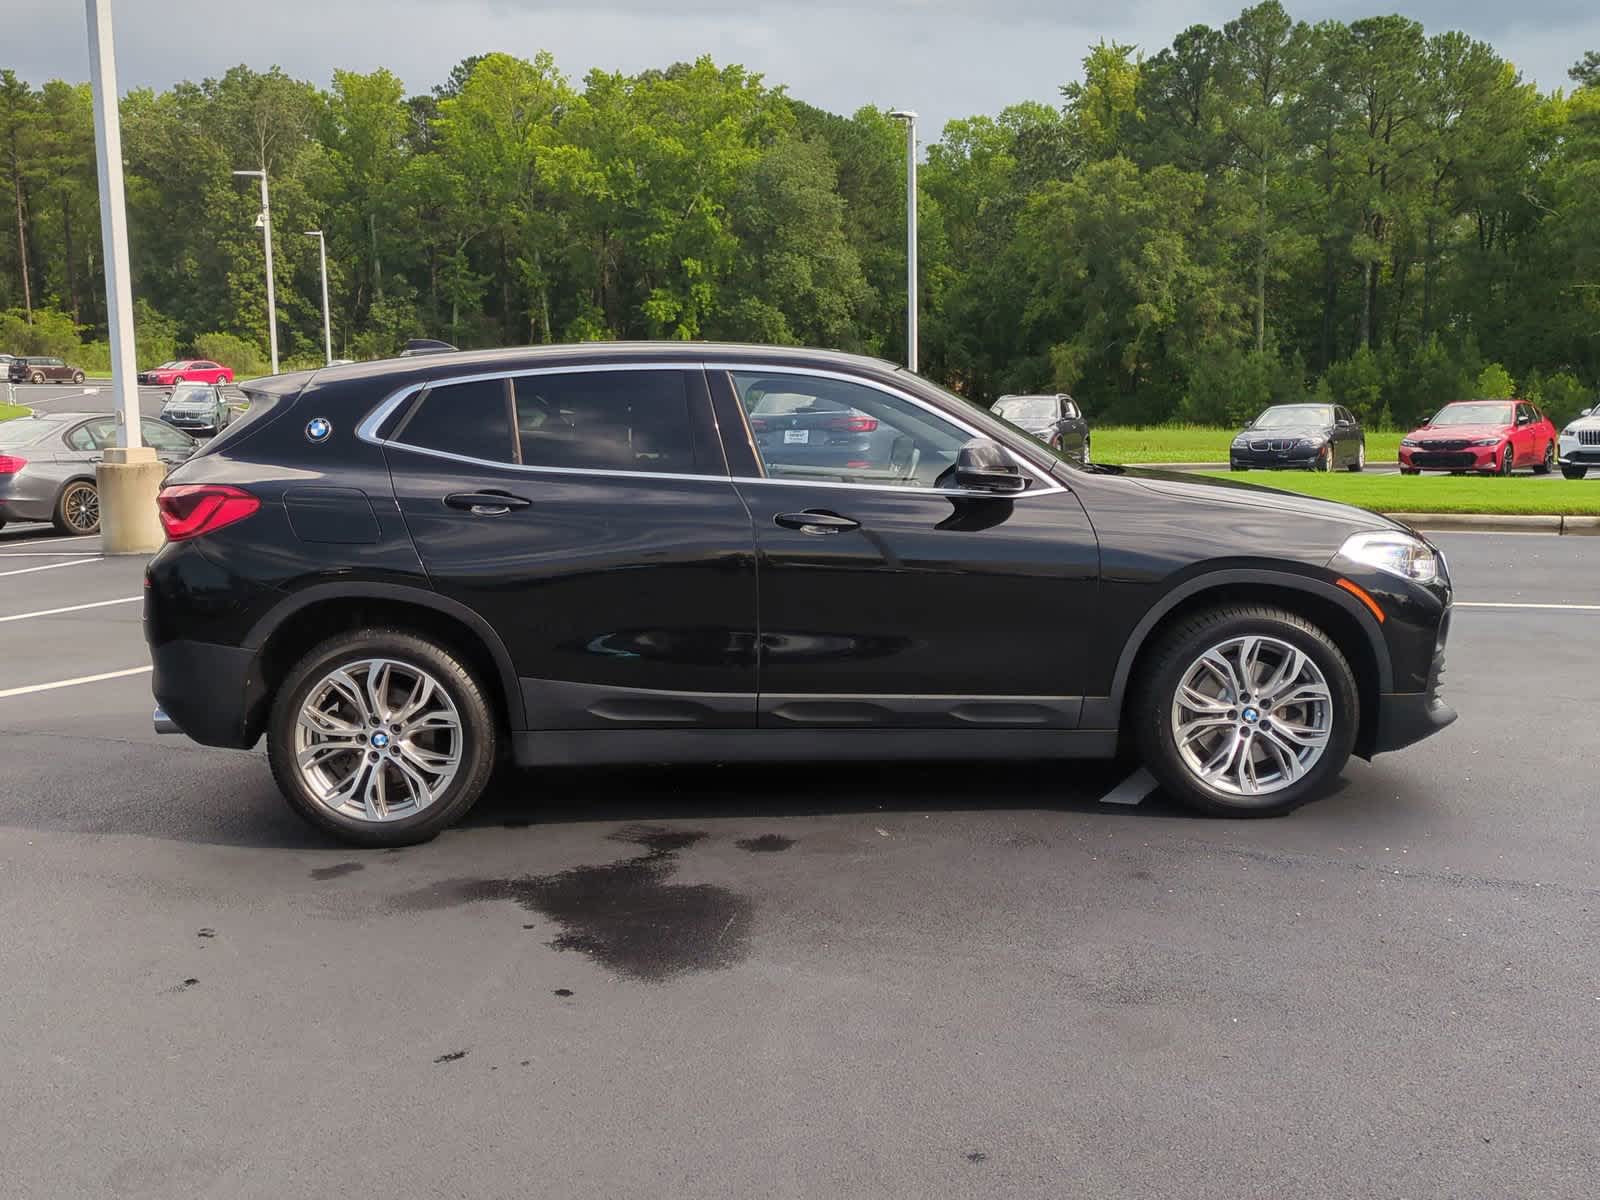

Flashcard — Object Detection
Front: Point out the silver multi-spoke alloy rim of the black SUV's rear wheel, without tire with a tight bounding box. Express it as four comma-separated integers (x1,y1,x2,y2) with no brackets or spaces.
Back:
294,658,462,821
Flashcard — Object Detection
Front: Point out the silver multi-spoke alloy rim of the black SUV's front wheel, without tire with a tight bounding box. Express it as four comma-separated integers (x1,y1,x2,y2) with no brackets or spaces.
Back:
1171,635,1333,797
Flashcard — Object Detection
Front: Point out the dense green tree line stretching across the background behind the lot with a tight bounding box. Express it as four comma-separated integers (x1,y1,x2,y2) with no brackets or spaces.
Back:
0,0,1600,424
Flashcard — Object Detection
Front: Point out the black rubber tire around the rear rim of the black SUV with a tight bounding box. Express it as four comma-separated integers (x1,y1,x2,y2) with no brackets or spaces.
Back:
267,627,501,846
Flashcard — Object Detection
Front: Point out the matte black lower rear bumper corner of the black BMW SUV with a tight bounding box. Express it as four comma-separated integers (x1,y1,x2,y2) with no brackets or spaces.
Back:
150,640,267,749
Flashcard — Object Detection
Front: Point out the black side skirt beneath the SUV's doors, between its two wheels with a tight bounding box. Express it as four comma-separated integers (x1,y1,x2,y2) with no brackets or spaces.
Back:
512,730,1117,766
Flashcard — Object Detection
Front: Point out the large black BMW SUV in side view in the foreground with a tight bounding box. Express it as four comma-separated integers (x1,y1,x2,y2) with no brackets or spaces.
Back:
146,344,1454,845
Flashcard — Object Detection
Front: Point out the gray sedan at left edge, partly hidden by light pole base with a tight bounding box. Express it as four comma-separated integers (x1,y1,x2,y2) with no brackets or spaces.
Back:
0,413,198,536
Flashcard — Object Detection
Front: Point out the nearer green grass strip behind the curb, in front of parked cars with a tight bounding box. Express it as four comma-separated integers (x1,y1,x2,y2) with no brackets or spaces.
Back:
1211,470,1600,517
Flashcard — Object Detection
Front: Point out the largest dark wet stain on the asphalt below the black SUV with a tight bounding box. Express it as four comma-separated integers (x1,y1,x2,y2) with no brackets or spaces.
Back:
394,826,754,984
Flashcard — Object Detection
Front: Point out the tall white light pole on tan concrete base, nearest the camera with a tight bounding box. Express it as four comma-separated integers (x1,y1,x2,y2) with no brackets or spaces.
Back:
86,0,166,554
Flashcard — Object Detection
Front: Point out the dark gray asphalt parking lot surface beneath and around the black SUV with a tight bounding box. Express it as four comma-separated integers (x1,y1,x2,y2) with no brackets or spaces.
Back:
0,528,1600,1200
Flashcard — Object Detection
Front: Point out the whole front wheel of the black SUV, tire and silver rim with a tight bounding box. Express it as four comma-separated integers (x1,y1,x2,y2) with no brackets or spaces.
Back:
1133,605,1360,816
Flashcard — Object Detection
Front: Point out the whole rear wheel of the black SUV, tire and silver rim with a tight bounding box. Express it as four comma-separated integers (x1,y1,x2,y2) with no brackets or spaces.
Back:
267,629,498,846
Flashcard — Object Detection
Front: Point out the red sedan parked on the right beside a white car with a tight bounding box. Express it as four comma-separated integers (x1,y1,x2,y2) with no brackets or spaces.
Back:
1400,400,1555,475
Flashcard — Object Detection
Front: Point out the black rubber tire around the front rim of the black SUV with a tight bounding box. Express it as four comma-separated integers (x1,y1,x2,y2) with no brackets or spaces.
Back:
1130,605,1360,818
